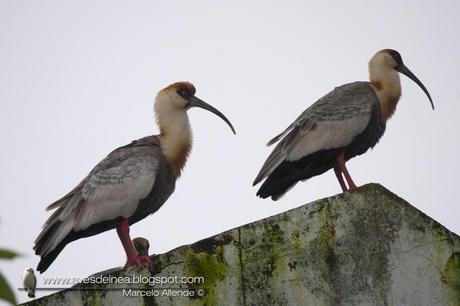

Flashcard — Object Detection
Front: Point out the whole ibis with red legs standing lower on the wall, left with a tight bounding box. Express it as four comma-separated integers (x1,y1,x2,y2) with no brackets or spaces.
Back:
33,82,235,273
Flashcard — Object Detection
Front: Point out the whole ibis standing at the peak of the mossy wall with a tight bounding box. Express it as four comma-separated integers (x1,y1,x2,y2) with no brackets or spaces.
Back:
253,49,434,201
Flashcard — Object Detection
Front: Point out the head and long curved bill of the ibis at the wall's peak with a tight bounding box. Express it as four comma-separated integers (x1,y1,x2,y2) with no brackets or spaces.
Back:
369,49,434,109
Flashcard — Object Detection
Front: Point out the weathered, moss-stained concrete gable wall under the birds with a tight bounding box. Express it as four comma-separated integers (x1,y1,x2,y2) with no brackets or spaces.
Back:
24,184,460,306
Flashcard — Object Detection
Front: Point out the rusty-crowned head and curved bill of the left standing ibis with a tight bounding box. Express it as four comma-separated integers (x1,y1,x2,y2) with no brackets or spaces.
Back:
155,82,235,134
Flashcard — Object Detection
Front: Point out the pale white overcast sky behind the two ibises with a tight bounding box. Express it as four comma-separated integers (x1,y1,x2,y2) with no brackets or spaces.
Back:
0,1,460,301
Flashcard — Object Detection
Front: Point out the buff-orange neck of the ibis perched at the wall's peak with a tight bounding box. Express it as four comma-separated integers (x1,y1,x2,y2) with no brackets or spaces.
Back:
369,60,401,121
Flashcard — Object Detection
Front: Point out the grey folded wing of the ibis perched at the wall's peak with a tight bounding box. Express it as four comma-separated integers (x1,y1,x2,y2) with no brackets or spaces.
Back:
254,82,379,185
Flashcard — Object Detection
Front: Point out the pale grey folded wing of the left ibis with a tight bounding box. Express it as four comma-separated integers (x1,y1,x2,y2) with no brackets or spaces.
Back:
35,136,164,255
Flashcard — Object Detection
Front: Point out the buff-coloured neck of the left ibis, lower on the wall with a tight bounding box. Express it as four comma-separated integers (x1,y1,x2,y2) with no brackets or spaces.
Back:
155,103,192,177
